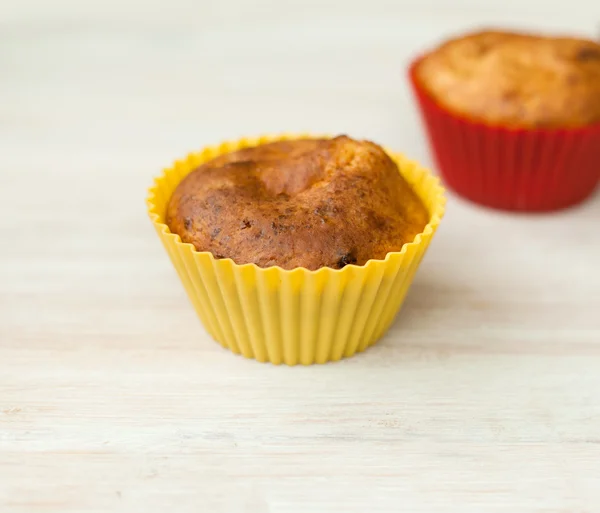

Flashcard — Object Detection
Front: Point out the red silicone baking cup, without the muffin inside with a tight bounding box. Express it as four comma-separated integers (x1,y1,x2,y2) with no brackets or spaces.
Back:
409,60,600,212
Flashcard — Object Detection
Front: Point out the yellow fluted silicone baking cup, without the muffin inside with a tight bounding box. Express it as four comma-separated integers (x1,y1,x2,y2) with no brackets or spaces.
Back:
147,134,445,365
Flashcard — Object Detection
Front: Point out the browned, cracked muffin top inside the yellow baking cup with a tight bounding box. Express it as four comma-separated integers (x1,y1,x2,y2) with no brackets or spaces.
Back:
166,136,429,270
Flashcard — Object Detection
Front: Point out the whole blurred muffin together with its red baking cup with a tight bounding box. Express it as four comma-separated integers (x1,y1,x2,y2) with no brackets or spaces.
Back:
410,31,600,211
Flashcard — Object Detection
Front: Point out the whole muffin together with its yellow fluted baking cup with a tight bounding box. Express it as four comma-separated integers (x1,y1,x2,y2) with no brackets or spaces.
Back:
148,136,444,365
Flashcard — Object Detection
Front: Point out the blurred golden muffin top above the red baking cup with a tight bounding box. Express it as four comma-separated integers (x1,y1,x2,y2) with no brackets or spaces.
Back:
415,31,600,128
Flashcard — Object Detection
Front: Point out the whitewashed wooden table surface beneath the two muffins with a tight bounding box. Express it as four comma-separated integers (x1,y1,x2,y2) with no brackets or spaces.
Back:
0,0,600,513
